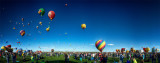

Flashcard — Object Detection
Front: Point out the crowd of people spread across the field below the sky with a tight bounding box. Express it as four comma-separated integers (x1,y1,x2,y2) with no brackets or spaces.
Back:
0,51,160,63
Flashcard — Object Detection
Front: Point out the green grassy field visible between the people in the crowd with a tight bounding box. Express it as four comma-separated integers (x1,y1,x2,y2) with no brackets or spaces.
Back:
0,55,158,63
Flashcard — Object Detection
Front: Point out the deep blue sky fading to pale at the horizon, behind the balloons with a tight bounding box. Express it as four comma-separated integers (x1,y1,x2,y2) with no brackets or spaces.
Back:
0,0,160,52
